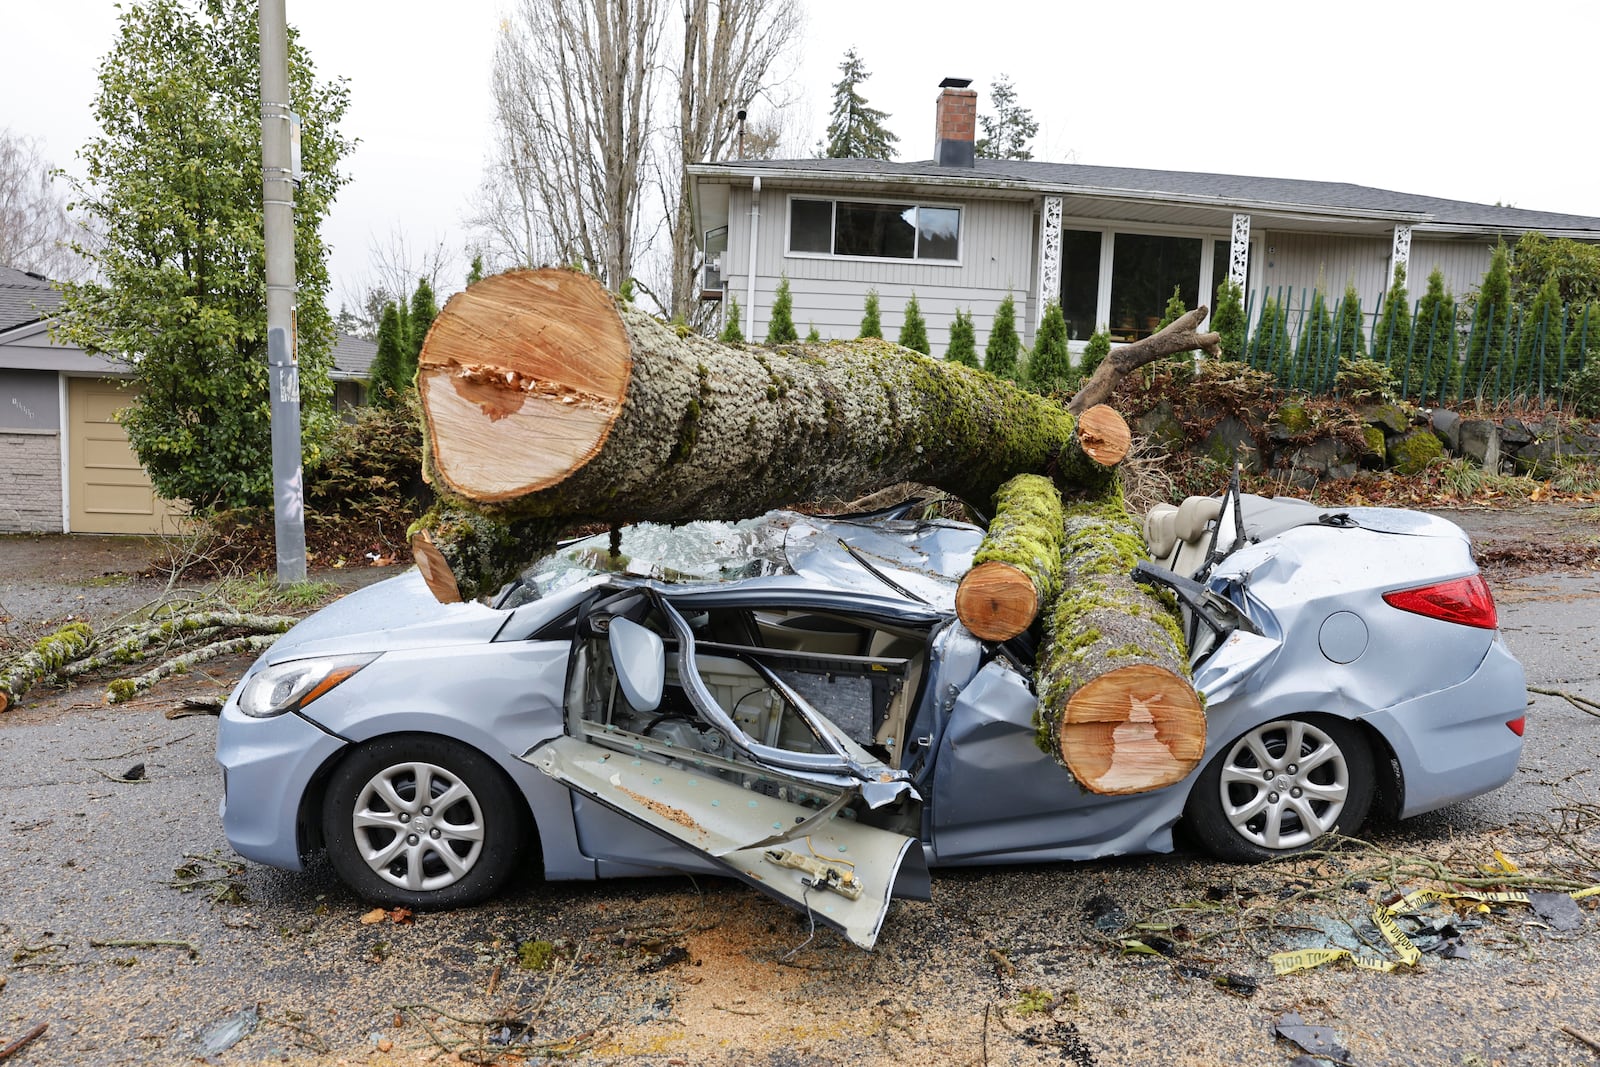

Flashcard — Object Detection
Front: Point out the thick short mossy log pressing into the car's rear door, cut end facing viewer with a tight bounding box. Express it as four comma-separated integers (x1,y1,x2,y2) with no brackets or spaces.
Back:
1034,493,1205,793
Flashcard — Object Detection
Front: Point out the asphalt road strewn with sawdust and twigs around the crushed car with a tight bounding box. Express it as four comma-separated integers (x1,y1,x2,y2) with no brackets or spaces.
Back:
0,518,1600,1067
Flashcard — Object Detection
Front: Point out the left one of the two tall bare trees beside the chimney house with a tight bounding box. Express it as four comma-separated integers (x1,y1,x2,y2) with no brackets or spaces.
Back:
491,0,661,288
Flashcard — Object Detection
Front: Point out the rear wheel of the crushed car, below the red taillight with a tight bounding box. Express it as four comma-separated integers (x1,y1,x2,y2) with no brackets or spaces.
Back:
1184,715,1376,862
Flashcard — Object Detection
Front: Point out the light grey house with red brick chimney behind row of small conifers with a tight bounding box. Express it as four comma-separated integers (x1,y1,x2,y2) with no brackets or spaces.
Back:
690,78,1600,355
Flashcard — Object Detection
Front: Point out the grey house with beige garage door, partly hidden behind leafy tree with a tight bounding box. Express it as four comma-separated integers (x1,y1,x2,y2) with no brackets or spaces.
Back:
0,267,378,534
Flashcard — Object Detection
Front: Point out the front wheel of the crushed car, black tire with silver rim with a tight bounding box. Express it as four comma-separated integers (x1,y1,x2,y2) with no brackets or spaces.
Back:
322,734,531,909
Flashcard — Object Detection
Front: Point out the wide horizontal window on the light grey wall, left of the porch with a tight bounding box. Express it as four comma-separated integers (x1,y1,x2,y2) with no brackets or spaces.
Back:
789,197,962,262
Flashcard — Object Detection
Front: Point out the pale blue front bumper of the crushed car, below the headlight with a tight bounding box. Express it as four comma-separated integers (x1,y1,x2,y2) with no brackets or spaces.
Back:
216,702,346,870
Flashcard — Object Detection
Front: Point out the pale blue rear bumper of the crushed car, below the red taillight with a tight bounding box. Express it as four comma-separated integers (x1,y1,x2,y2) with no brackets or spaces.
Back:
1363,637,1528,817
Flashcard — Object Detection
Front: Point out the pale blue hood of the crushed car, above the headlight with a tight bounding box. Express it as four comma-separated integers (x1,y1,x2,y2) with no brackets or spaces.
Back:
262,566,506,662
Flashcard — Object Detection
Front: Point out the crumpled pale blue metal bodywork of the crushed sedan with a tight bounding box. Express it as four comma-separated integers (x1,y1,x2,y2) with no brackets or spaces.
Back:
218,498,1525,921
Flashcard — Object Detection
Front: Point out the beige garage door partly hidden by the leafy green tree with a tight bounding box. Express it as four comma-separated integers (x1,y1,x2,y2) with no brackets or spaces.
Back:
67,378,178,534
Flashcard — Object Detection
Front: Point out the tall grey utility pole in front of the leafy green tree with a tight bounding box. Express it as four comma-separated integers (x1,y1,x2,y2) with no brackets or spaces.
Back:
259,0,306,585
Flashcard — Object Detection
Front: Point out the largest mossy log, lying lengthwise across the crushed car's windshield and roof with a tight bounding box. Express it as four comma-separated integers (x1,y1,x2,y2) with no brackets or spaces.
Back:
411,270,1128,601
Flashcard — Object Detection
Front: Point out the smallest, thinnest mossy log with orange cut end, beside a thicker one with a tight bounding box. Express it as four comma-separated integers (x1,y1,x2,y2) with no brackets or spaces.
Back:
955,474,1066,641
